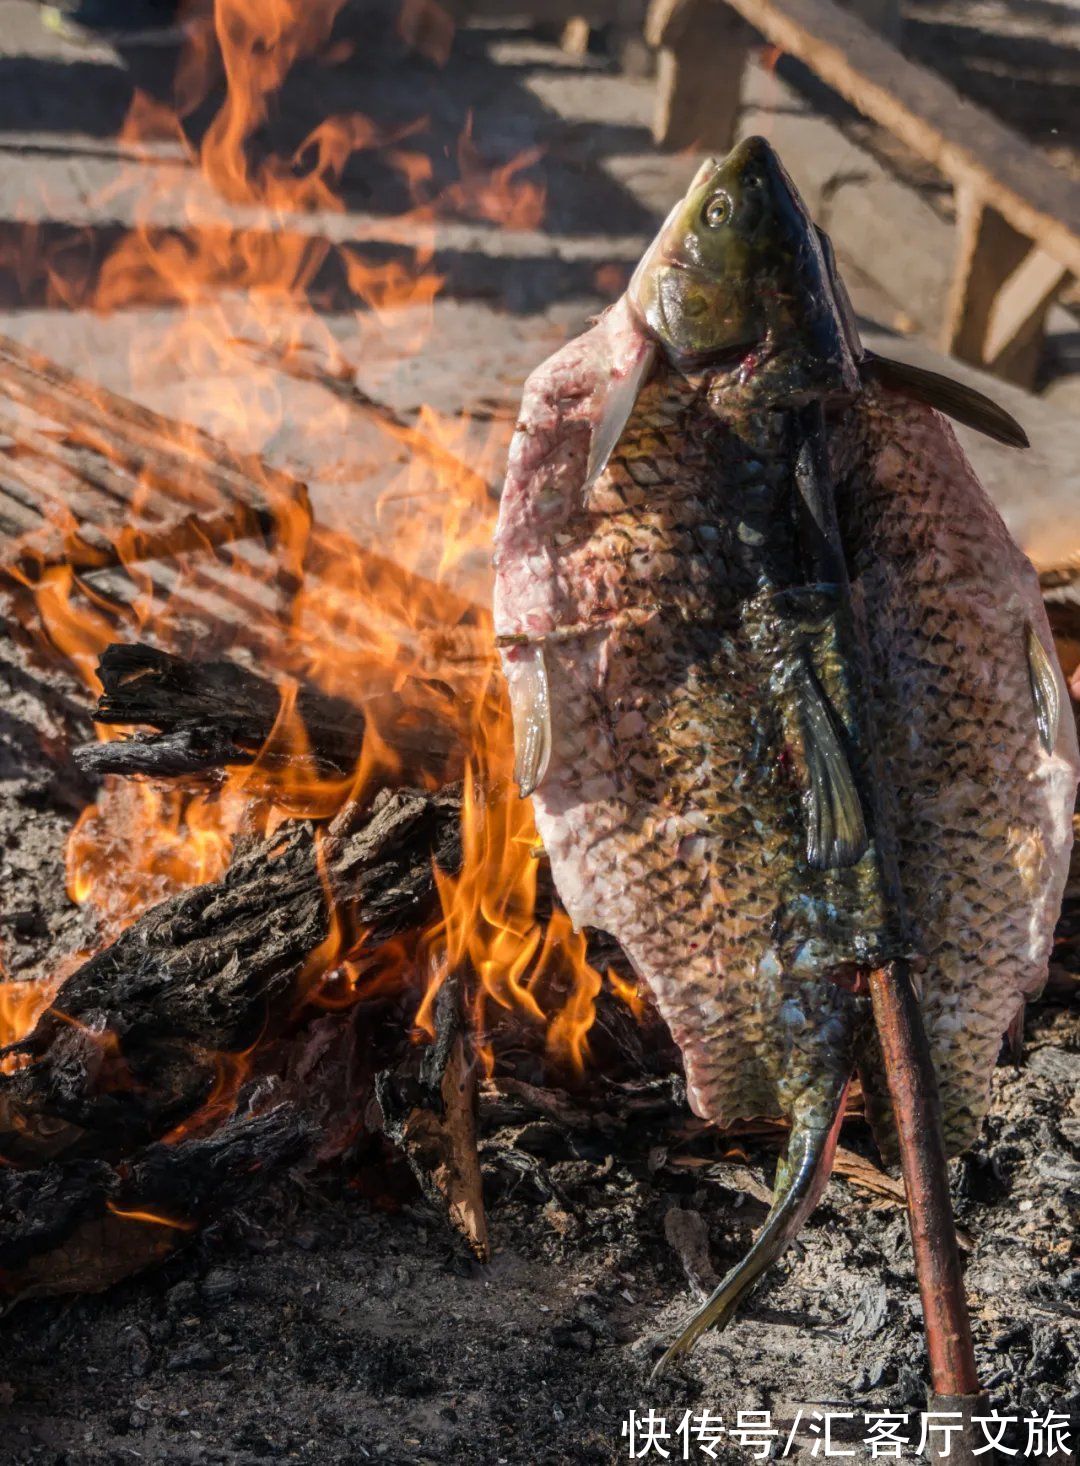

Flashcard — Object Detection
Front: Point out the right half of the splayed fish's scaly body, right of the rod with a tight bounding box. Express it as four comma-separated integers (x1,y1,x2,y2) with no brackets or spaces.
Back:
835,391,1077,1152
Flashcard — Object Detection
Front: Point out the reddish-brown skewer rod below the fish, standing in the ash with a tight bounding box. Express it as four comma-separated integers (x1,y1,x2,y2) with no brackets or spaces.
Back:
870,962,979,1396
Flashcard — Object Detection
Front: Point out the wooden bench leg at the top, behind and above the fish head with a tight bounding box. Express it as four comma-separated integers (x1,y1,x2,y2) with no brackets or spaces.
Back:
645,0,753,152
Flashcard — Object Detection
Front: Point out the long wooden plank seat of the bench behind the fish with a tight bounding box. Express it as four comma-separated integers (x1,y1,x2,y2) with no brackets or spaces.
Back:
717,0,1080,274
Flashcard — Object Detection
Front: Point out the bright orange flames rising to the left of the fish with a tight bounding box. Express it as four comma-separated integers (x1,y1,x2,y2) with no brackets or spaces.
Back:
8,0,609,1143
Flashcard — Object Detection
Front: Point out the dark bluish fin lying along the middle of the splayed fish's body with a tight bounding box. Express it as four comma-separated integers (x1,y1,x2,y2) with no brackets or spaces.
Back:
797,664,869,871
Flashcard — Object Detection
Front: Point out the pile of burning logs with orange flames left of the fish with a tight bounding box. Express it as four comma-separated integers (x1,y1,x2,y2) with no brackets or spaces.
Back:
0,249,615,1292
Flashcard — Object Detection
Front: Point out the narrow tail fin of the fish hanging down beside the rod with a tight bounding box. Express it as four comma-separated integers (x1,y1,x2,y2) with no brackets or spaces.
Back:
651,1083,848,1380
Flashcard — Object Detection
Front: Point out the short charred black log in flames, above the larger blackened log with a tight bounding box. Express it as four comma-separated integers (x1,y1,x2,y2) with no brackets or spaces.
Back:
73,644,453,778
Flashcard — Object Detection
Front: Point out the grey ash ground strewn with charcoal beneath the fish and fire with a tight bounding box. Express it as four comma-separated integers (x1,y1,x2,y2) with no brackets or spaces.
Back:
0,636,1080,1466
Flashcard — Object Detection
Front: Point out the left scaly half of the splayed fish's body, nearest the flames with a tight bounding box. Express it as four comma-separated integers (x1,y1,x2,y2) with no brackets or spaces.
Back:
518,374,885,1123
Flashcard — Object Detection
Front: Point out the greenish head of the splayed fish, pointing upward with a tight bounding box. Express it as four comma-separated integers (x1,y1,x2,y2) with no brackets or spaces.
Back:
627,138,856,400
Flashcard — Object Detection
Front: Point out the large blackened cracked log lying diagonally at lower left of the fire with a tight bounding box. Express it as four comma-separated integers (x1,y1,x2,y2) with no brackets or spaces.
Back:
0,789,460,1164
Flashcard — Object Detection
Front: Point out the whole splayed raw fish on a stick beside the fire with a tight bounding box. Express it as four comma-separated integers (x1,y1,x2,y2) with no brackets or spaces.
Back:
495,138,1079,1353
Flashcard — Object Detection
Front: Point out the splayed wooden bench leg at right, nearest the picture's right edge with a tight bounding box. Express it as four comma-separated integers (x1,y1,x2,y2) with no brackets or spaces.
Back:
941,189,1068,387
